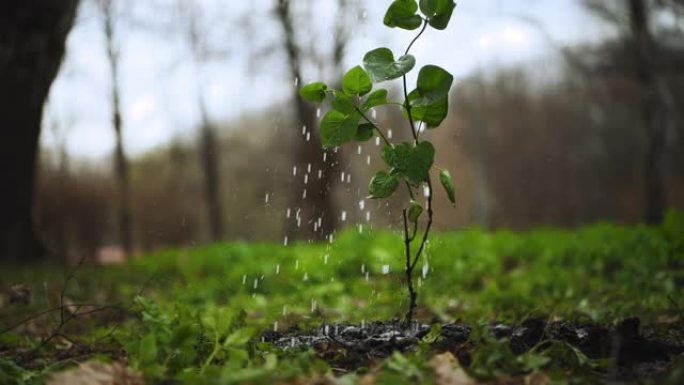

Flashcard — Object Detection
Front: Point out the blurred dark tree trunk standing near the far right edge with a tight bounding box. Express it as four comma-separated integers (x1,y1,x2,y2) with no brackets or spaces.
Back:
629,0,666,224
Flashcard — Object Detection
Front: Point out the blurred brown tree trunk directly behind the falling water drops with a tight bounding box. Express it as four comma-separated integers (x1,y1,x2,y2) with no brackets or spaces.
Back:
276,0,339,240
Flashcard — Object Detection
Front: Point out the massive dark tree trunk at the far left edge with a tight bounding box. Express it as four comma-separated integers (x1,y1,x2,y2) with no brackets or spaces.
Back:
0,0,78,262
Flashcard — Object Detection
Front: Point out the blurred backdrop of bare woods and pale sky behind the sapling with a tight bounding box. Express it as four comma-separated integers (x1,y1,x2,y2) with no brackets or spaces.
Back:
9,0,684,260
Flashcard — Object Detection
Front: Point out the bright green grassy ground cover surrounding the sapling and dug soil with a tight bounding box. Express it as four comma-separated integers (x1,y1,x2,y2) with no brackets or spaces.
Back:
0,213,684,384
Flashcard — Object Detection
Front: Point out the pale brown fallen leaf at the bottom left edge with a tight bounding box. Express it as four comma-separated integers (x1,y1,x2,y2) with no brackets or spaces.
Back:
46,361,145,385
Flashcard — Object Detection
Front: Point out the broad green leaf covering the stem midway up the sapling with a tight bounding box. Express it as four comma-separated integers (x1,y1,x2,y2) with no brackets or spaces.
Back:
382,142,435,185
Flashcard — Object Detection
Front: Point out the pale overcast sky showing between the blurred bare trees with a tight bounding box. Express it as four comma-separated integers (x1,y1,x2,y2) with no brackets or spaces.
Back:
41,0,605,160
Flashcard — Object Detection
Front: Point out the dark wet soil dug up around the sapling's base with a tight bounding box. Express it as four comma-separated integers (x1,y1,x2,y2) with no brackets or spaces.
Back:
261,317,684,380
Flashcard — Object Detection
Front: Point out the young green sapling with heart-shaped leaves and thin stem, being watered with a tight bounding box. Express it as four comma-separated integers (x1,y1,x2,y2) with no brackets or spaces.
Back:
299,0,456,327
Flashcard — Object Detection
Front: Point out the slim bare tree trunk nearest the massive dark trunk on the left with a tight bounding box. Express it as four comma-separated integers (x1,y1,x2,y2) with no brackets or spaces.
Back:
98,0,133,254
